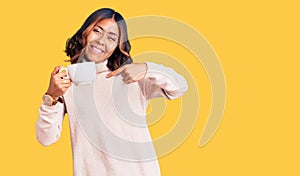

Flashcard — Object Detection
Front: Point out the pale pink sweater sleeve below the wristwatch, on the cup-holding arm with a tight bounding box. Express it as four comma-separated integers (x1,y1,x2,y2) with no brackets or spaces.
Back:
36,100,64,146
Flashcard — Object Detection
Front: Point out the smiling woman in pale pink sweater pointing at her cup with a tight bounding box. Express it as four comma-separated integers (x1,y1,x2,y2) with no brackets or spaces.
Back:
36,8,187,176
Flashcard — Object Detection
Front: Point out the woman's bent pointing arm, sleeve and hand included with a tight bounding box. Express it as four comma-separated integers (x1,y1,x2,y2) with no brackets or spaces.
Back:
106,62,188,99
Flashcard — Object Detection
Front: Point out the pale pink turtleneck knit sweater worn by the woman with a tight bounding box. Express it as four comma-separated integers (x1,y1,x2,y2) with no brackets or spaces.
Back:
36,61,188,176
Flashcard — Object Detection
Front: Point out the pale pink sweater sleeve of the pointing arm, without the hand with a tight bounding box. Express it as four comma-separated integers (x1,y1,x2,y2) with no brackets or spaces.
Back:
139,62,188,100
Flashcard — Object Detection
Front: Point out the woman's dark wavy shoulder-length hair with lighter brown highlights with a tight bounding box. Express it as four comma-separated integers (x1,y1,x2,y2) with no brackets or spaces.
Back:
65,8,132,71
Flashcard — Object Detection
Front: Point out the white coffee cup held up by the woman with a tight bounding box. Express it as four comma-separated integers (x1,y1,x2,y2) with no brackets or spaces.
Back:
60,62,96,86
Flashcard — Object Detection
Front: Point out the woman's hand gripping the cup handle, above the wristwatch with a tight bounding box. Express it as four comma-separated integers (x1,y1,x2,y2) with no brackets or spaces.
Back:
47,66,71,99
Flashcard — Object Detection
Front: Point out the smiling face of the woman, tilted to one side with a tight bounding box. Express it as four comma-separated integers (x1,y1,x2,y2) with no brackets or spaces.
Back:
85,19,119,63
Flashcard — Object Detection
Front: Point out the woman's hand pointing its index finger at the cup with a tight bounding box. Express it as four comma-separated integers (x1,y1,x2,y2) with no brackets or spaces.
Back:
106,63,147,84
